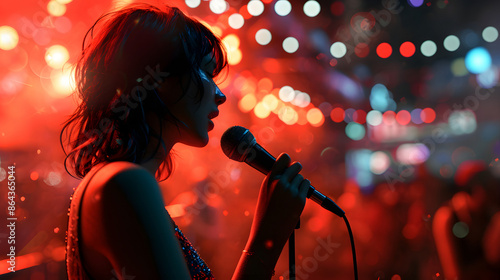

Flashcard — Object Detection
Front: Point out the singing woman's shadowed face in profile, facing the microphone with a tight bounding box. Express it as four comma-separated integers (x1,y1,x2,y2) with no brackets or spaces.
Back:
160,54,226,147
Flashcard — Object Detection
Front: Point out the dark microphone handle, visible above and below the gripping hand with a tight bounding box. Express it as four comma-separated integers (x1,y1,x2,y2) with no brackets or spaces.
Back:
243,143,345,218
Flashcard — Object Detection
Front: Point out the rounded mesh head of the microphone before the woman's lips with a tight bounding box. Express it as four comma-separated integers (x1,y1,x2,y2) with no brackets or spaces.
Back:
220,126,256,161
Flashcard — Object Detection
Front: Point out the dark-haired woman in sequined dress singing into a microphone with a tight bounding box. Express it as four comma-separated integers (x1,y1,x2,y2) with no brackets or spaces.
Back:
61,4,309,280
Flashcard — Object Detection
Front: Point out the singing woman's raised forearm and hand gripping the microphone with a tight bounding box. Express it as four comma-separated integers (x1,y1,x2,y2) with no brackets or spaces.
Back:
233,154,310,280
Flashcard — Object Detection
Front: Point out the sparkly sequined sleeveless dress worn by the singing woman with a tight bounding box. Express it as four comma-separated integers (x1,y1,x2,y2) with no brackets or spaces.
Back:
66,167,215,280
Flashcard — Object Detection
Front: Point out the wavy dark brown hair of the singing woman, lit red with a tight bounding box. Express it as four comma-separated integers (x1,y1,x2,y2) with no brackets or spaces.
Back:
60,4,227,180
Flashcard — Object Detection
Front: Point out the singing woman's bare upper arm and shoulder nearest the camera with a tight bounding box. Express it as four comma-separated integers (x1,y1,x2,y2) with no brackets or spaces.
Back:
93,164,190,280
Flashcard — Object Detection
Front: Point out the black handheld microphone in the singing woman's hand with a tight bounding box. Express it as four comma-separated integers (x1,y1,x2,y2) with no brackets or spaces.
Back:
220,126,345,217
